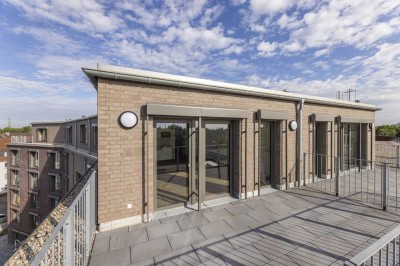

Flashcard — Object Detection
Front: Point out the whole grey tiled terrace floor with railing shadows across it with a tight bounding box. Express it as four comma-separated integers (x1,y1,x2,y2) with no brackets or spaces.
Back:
90,187,400,266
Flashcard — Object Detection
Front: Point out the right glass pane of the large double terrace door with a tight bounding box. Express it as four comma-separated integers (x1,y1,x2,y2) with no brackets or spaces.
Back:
205,122,230,199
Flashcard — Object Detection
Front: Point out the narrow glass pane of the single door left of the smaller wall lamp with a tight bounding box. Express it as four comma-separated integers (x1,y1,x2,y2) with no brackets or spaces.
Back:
260,122,272,186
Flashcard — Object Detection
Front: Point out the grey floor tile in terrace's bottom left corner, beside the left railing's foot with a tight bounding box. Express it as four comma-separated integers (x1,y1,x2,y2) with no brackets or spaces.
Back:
89,247,131,266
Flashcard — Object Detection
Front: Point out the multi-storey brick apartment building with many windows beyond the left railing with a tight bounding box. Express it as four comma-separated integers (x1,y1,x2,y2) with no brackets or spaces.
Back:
7,116,97,242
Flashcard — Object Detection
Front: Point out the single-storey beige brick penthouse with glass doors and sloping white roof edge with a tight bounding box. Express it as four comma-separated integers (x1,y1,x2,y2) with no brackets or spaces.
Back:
83,65,379,231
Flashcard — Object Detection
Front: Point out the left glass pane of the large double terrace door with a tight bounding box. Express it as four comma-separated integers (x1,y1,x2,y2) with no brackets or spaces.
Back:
156,123,189,208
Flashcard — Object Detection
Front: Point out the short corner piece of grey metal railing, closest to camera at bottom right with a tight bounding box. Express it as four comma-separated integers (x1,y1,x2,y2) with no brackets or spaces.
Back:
345,225,400,266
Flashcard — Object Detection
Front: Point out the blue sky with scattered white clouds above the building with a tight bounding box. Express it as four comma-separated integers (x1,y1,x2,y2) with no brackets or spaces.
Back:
0,0,400,128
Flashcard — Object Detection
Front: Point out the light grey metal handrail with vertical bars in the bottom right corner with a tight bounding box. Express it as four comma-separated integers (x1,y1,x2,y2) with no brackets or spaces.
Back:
345,225,400,266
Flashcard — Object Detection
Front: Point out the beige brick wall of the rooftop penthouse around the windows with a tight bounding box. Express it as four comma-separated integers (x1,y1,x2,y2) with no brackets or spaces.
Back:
98,78,375,223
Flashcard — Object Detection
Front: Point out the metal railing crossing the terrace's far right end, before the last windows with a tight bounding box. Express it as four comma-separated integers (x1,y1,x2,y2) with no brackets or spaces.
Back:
302,153,400,211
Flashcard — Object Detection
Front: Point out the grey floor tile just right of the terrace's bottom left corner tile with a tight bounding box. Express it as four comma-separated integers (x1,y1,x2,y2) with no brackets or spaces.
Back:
131,237,172,263
